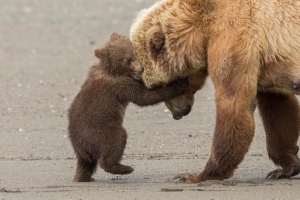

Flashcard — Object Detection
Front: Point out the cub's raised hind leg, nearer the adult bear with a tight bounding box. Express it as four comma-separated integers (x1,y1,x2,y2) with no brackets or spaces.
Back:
99,127,134,174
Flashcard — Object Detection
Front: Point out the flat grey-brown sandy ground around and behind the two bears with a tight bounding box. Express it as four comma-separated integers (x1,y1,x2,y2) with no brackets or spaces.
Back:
0,0,300,200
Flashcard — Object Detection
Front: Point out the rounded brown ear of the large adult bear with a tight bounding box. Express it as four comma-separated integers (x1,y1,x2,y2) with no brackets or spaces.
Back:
146,27,165,60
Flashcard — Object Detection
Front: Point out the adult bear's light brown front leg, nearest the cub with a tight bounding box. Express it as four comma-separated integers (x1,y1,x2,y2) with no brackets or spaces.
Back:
176,35,259,183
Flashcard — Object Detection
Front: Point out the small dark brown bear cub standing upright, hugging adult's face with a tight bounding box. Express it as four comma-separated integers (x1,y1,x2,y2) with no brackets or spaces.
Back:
68,33,188,182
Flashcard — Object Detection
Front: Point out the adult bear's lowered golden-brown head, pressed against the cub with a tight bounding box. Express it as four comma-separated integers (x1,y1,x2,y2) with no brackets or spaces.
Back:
130,1,207,119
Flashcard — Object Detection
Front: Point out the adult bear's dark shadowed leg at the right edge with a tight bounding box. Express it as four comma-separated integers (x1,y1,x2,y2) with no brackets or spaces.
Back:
257,92,300,179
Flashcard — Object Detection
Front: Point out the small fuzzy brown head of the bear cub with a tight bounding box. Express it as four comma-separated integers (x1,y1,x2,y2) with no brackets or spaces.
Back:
94,33,144,80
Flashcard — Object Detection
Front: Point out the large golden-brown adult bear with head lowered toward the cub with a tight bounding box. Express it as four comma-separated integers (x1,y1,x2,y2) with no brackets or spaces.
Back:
131,0,300,183
